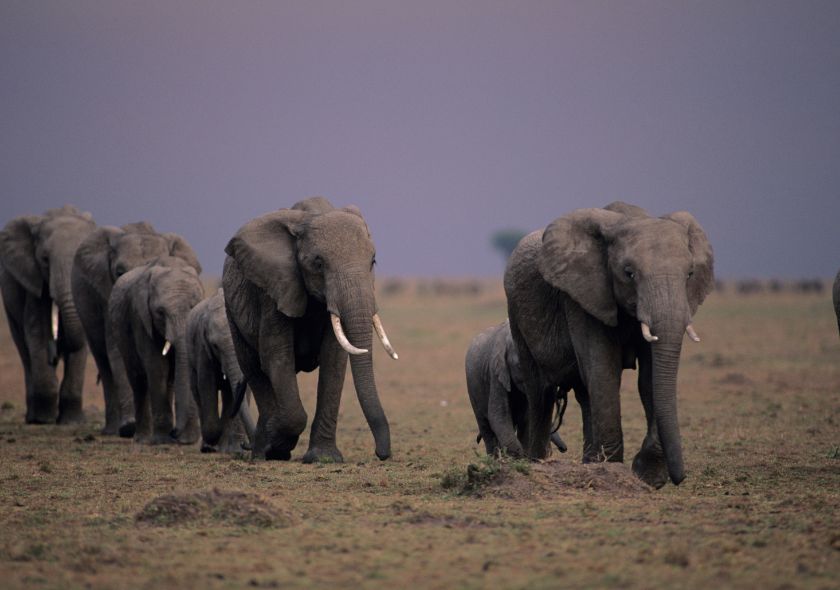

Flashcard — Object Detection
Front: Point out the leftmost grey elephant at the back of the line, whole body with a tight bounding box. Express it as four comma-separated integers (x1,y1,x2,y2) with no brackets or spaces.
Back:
0,206,96,424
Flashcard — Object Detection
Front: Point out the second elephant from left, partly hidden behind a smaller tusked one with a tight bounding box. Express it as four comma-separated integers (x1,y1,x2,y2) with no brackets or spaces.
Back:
72,222,201,438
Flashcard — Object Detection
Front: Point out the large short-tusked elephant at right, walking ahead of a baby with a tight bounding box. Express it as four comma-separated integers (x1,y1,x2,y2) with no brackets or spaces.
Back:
505,203,714,487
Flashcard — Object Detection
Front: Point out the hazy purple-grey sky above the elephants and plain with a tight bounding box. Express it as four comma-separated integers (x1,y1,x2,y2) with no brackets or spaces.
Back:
0,0,840,277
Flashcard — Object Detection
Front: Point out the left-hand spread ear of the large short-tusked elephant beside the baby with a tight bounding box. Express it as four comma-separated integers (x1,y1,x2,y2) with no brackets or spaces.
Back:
537,209,624,326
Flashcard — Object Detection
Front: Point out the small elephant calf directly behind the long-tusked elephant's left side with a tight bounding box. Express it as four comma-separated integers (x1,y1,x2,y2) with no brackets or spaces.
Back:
187,289,255,453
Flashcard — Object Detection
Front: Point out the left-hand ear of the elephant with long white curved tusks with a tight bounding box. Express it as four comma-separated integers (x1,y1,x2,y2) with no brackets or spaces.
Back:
225,209,308,318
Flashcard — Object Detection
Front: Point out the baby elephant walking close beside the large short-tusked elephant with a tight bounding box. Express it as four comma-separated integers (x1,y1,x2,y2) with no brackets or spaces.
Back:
466,321,567,457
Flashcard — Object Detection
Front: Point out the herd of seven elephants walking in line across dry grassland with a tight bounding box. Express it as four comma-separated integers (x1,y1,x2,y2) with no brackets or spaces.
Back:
0,197,720,487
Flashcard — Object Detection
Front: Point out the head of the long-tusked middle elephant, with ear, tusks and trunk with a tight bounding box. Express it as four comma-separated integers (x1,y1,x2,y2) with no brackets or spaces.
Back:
225,198,397,459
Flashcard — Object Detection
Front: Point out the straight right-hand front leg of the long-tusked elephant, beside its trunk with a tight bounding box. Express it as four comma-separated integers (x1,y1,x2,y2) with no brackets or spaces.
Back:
303,330,347,463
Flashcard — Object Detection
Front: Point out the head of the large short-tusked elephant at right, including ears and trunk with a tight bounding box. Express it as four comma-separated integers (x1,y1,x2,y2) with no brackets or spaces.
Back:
538,203,714,483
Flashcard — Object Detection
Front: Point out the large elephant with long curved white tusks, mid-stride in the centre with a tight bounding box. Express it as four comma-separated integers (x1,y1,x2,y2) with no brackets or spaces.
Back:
222,197,397,463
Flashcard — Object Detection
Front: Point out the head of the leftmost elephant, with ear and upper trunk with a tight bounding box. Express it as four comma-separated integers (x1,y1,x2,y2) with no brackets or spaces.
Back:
0,205,96,350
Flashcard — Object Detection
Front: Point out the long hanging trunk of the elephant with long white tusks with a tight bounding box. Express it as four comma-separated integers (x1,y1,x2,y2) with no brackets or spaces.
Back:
337,274,391,460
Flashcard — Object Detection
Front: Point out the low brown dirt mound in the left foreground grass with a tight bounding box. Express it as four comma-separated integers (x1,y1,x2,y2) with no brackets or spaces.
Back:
135,489,295,528
